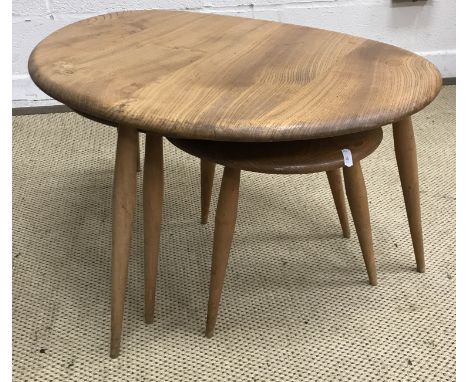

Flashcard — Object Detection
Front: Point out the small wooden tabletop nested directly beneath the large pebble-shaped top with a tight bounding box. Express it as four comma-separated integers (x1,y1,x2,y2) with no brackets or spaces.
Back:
168,128,383,174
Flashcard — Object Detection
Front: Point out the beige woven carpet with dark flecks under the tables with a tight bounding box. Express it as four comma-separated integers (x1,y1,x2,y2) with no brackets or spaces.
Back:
13,86,455,382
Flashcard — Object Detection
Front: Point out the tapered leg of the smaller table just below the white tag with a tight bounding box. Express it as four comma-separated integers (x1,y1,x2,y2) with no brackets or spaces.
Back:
343,162,377,285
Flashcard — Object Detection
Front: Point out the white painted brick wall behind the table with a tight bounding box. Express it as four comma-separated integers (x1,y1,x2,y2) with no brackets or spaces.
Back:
13,0,456,107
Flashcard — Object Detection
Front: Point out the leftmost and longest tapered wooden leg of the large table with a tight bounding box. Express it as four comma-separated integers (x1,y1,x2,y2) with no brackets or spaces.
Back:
110,127,138,358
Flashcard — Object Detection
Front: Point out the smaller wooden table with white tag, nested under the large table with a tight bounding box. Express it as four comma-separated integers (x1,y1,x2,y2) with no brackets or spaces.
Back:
169,129,382,338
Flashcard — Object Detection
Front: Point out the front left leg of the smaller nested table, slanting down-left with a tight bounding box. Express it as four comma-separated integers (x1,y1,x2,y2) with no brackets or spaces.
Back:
205,167,240,338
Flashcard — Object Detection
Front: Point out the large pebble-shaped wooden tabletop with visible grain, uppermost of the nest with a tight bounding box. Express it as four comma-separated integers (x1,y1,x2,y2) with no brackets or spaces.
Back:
29,10,442,141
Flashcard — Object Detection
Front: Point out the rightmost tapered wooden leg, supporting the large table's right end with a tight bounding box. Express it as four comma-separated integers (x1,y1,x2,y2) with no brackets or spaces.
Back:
393,117,426,273
